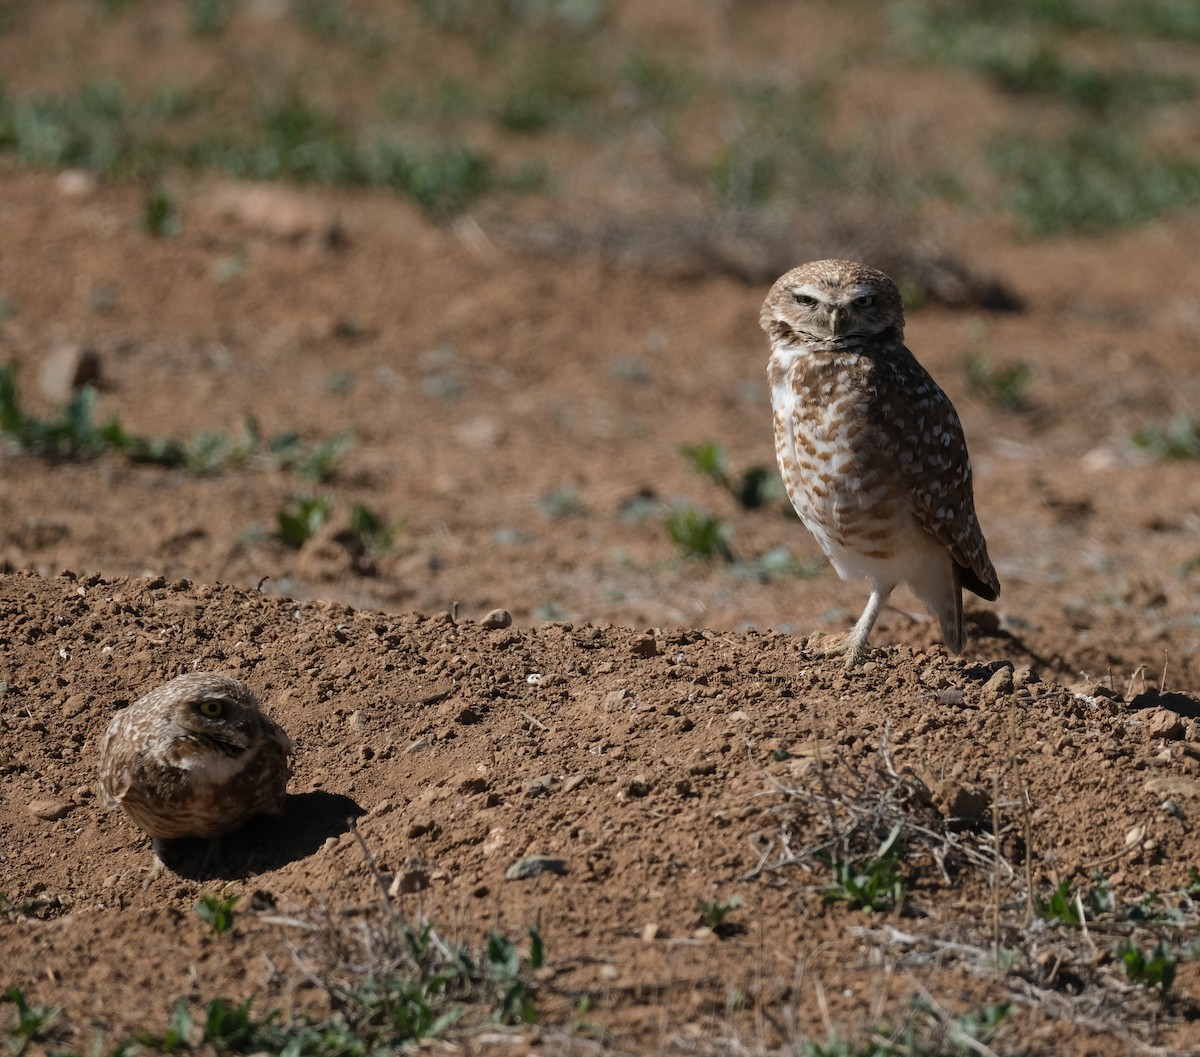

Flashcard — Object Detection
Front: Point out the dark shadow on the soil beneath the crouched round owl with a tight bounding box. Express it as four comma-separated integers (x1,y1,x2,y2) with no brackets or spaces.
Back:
157,789,366,881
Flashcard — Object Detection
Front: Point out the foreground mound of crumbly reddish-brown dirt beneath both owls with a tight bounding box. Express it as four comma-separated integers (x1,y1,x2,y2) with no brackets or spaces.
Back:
0,575,1200,1053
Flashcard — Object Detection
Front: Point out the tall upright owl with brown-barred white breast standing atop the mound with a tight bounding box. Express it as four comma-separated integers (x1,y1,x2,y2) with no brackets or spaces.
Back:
758,260,1000,667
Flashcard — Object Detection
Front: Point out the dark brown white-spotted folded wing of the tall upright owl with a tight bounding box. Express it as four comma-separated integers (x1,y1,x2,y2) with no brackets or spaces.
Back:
876,349,1000,601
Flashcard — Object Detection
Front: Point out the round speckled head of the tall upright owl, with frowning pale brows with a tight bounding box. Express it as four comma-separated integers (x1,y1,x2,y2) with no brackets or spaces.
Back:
758,260,904,346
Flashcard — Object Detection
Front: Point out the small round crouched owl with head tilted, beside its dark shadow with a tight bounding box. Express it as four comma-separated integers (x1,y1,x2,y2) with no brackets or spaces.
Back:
100,672,292,859
